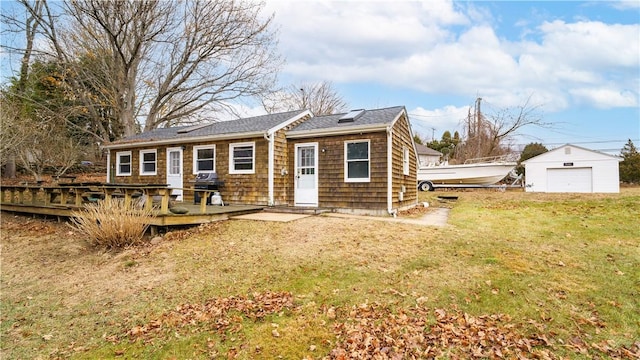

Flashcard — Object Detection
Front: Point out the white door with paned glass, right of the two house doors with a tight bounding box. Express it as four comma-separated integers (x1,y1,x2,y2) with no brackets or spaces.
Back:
294,143,318,206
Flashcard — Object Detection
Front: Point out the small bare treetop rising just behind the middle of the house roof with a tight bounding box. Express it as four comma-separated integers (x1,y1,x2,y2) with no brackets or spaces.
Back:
262,81,347,115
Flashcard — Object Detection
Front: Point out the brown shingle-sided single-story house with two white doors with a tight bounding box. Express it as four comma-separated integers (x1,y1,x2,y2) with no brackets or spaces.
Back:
104,106,417,215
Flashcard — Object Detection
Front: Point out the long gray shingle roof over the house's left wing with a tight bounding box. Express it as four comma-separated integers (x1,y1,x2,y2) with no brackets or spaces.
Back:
112,110,305,144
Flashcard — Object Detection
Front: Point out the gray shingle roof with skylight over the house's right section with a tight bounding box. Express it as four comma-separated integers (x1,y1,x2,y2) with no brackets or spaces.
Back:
291,106,404,132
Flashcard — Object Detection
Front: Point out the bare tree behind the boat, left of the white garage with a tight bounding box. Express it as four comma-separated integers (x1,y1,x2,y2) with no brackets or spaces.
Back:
455,96,550,162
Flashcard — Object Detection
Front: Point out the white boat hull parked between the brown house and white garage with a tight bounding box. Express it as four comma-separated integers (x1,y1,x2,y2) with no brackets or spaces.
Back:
417,162,517,185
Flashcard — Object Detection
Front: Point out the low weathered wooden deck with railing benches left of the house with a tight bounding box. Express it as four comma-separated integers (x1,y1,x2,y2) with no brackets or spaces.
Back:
0,184,264,231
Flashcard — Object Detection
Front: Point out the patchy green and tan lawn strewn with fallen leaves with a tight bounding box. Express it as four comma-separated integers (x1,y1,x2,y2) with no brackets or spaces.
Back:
0,188,640,359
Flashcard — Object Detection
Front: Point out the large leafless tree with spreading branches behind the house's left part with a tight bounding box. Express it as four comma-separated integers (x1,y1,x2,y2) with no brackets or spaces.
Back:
6,0,282,141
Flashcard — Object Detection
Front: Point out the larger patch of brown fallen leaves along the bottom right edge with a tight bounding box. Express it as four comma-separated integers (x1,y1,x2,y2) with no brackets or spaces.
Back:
328,304,640,359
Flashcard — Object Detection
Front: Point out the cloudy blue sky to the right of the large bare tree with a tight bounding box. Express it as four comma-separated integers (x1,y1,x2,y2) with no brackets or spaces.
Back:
267,0,640,153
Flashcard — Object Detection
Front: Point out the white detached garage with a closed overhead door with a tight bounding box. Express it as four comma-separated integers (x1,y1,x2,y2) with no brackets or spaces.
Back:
522,144,622,193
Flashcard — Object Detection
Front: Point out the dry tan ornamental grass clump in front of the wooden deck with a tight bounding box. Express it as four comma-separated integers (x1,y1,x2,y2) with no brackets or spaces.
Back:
71,199,154,249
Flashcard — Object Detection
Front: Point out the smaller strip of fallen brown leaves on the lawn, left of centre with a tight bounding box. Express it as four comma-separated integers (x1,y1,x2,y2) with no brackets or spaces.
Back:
121,291,293,341
